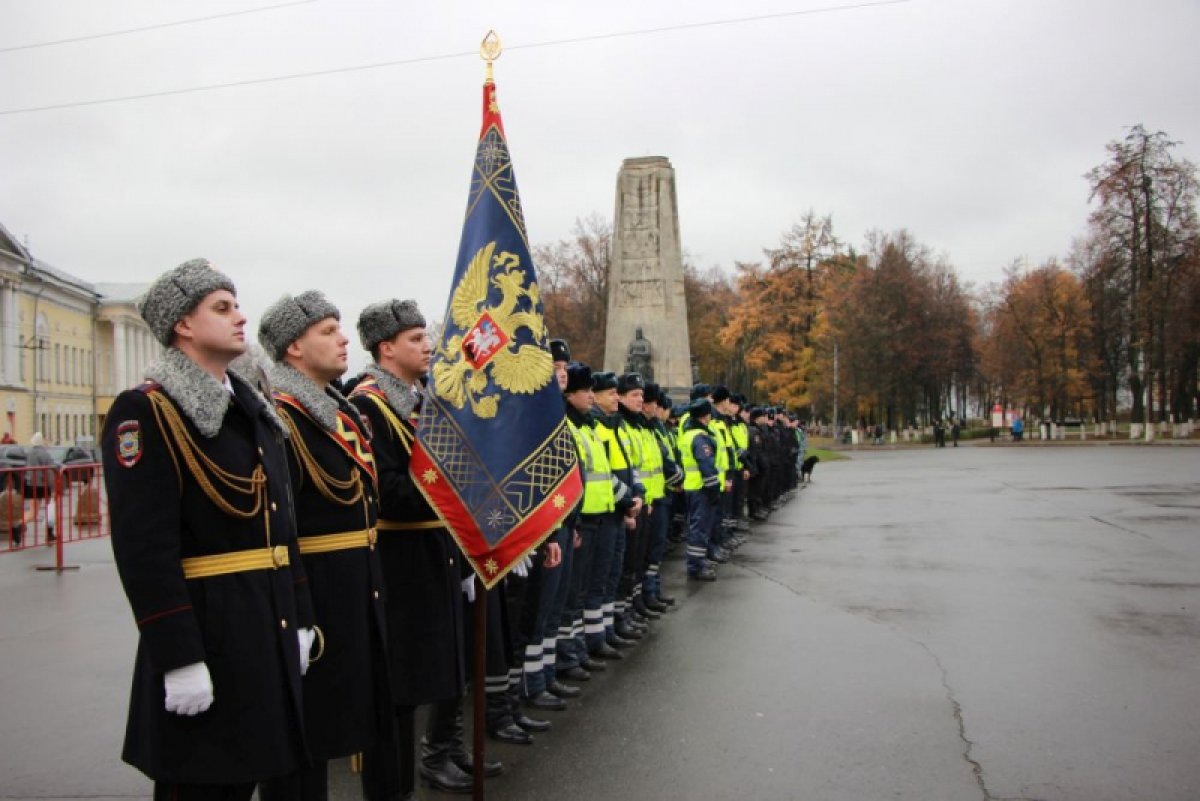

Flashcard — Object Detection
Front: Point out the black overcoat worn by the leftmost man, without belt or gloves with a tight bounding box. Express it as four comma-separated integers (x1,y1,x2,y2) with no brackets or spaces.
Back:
102,374,313,784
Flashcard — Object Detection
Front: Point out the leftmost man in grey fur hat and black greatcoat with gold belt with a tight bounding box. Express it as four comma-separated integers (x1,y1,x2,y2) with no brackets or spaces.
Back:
102,259,313,801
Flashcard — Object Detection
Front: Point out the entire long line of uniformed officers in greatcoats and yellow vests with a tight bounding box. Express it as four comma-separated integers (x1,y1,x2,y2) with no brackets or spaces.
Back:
102,259,804,801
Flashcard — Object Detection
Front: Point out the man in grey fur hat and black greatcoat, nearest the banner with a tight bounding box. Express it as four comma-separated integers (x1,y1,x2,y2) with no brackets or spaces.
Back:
349,300,474,795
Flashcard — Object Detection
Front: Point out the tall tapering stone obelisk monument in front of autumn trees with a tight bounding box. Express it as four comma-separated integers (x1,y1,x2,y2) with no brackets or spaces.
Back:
604,156,691,402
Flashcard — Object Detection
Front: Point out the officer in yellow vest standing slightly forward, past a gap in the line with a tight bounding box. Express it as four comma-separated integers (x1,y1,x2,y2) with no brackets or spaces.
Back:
679,398,721,582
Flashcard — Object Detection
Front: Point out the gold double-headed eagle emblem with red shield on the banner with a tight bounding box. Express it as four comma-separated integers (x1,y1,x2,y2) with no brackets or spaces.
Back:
433,242,554,418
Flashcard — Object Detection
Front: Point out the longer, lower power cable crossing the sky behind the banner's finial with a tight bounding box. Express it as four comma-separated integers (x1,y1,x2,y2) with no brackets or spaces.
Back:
0,0,912,116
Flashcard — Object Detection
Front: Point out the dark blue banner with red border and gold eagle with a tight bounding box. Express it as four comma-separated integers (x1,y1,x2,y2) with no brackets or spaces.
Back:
409,65,583,588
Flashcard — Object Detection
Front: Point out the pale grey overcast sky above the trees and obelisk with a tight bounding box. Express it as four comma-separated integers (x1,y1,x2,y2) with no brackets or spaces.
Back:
0,0,1200,352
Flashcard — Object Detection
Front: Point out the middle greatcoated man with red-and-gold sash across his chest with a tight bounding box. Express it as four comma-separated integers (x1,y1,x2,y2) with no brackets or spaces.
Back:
258,290,394,801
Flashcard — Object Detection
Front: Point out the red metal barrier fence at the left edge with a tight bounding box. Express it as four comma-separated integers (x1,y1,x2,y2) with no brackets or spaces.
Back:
0,463,109,570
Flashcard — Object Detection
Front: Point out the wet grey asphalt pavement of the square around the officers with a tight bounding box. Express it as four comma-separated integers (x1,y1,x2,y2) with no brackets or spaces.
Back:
0,445,1200,801
